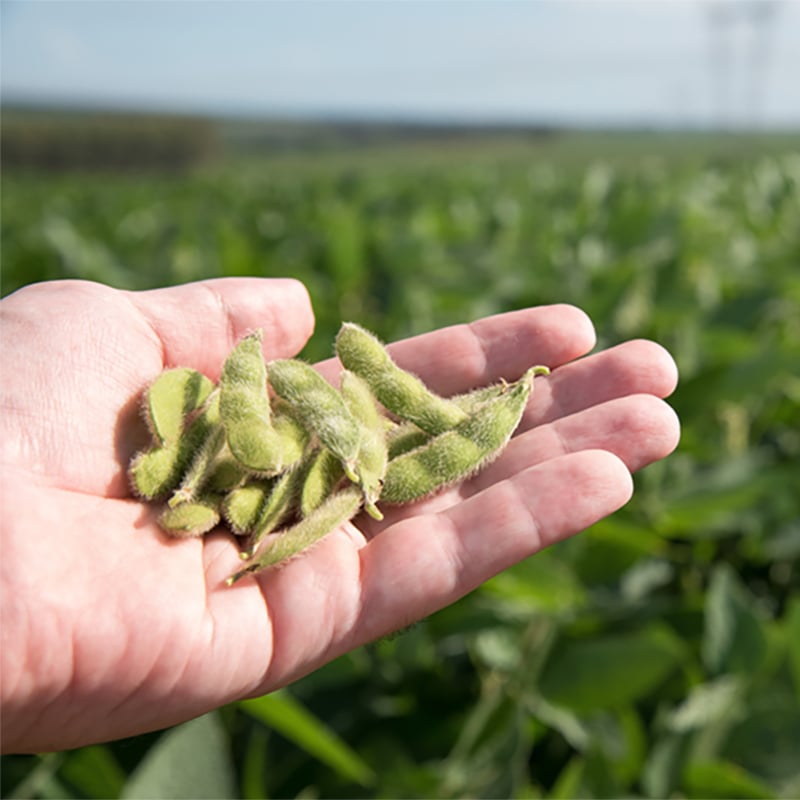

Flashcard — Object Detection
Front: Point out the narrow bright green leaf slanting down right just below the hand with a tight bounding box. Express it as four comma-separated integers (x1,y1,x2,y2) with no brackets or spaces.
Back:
238,690,375,786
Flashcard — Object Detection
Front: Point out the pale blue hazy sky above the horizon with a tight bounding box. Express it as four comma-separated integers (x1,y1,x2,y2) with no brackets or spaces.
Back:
0,0,800,129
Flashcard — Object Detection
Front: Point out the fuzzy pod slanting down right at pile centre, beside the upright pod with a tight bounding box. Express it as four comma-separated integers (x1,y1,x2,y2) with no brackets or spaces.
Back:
269,358,361,481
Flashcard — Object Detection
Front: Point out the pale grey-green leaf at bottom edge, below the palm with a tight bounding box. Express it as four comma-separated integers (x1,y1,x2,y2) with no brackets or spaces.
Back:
121,713,238,800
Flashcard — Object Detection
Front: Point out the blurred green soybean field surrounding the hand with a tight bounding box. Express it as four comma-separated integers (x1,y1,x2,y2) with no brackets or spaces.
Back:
2,119,800,798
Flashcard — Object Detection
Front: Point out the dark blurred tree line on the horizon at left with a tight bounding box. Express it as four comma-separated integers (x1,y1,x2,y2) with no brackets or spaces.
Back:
0,110,218,172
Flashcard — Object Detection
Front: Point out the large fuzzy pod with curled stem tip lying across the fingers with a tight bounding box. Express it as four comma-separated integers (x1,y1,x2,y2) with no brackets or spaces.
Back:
381,367,547,503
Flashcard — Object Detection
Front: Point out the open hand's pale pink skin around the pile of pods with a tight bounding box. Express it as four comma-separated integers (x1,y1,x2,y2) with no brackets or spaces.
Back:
0,279,679,752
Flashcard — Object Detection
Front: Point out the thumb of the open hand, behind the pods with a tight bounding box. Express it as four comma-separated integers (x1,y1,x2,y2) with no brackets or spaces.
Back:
128,278,314,380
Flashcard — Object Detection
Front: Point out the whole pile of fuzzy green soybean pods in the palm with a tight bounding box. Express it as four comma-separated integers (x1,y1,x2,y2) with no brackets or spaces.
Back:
129,323,549,584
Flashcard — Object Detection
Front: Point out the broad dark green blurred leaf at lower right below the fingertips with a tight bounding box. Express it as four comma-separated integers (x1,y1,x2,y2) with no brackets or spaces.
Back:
539,627,680,711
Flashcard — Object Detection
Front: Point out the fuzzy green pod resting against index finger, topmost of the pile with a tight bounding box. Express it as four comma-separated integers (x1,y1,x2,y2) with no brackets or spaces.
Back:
336,322,467,434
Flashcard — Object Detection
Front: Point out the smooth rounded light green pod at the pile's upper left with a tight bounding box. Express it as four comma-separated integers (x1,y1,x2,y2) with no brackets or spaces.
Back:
144,367,214,444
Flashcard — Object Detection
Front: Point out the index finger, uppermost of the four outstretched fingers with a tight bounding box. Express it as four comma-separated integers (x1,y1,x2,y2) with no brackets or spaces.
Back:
320,305,595,396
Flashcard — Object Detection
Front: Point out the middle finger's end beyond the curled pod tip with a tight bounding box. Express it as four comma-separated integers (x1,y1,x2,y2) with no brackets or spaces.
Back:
519,339,678,431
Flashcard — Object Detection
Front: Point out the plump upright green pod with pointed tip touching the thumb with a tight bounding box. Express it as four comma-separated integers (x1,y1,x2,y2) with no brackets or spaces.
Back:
219,330,283,474
